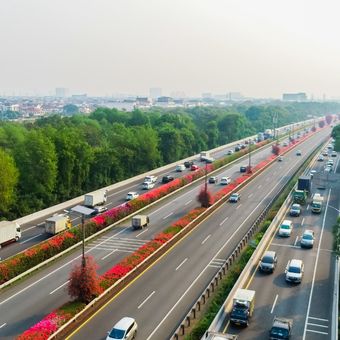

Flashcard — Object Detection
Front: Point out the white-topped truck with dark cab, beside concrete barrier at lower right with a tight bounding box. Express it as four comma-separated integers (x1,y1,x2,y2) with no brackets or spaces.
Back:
230,288,255,326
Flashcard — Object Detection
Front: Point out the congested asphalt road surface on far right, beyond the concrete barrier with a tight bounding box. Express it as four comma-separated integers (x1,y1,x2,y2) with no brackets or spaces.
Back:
227,147,340,340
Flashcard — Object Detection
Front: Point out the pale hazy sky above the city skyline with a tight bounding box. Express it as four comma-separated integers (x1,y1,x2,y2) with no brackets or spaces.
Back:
0,0,340,98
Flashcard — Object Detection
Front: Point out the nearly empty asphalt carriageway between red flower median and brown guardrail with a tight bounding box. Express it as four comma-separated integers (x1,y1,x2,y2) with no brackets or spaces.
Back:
62,130,329,339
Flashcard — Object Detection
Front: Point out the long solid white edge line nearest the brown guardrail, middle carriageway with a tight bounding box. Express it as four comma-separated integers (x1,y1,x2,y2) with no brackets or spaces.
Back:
146,157,299,340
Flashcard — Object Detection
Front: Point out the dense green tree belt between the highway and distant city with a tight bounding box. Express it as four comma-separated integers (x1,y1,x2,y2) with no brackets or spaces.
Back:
0,103,340,219
